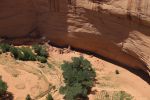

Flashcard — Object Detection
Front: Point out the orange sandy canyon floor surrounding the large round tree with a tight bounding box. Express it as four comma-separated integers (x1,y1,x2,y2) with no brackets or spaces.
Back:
0,45,150,100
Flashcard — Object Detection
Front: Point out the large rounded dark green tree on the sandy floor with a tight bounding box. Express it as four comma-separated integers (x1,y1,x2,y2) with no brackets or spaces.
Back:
60,57,96,100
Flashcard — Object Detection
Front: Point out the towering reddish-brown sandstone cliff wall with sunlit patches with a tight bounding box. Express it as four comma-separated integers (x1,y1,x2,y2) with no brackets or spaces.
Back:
0,0,150,72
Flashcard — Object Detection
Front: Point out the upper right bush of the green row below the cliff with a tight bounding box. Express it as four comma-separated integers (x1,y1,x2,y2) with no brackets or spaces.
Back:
32,44,48,58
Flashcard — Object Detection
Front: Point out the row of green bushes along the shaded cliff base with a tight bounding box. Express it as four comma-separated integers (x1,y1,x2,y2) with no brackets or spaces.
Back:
0,43,48,63
